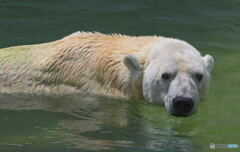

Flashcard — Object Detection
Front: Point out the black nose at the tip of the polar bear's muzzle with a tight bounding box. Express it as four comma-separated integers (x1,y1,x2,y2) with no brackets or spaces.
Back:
172,96,194,116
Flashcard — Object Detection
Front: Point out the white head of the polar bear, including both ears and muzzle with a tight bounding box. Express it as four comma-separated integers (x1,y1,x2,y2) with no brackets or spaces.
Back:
124,39,214,117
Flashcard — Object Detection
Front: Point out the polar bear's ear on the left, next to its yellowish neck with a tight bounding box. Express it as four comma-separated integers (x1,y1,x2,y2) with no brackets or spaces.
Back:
123,54,142,73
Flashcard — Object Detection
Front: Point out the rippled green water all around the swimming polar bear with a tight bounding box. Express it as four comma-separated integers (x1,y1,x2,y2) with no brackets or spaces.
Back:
0,0,240,152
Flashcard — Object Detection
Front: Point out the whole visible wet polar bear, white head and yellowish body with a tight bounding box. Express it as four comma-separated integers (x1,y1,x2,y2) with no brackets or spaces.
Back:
0,32,214,117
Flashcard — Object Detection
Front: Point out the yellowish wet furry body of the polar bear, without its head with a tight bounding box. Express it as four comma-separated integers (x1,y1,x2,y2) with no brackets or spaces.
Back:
0,32,156,97
